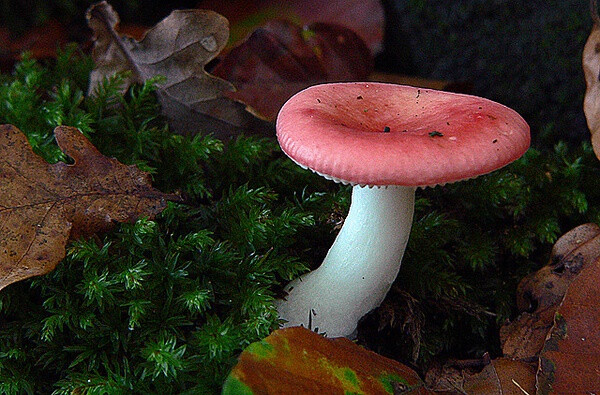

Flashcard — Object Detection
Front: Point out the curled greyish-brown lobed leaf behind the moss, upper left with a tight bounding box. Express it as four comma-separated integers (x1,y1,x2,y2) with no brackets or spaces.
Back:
87,1,274,138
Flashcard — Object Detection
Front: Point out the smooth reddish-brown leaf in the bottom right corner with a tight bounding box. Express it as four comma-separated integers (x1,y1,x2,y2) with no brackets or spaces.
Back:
537,258,600,394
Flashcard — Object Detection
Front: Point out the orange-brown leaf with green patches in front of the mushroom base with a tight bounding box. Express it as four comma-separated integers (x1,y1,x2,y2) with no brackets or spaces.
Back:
223,327,431,395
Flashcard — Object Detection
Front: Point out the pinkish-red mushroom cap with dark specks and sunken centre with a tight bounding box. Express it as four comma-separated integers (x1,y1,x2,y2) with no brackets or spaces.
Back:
277,82,530,186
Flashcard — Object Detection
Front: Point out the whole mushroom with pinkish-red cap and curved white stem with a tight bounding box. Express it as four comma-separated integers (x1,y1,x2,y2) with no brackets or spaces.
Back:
277,82,530,337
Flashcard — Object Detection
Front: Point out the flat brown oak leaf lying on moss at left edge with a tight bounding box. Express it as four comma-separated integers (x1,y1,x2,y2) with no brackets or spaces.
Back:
0,125,176,289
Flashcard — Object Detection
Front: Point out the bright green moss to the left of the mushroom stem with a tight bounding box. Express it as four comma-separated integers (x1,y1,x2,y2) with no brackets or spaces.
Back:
0,49,322,394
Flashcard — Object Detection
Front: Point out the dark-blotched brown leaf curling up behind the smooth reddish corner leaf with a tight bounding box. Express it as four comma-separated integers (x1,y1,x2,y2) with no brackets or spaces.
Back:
500,224,600,359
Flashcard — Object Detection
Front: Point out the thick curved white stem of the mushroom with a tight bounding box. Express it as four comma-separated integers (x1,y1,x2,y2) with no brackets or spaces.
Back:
277,186,415,337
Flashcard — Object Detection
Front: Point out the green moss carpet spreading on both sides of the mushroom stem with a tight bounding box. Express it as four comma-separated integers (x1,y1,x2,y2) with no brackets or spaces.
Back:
0,47,600,394
